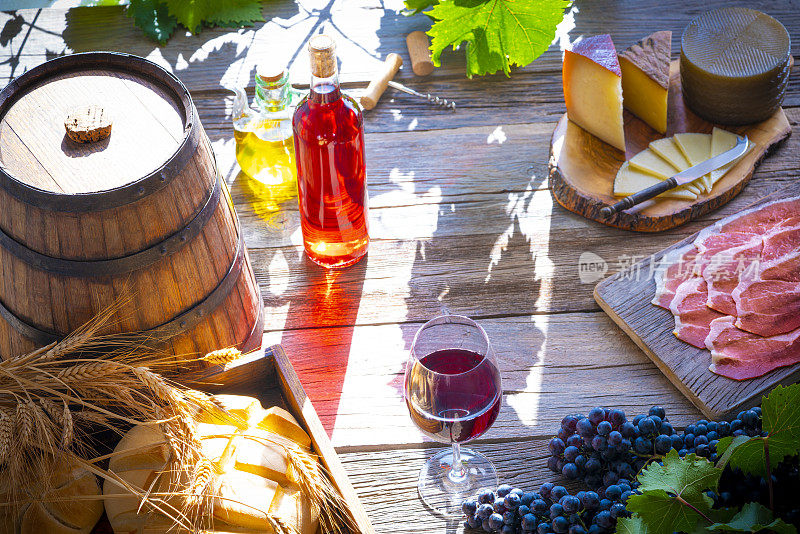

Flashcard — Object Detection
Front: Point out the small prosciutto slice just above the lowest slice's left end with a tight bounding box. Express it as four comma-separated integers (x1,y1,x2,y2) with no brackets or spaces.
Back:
669,276,723,349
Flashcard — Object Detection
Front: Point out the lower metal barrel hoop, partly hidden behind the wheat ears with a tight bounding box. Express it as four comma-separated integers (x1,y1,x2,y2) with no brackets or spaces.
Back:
0,234,247,346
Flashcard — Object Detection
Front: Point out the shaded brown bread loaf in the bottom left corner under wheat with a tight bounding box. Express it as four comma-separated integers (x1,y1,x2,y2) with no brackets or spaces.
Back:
0,465,103,534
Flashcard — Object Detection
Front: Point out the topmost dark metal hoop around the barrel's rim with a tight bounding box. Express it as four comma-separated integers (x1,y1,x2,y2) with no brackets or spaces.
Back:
0,52,202,212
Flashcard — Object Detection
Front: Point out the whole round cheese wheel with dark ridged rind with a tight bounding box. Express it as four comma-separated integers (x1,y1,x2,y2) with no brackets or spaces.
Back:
681,7,791,124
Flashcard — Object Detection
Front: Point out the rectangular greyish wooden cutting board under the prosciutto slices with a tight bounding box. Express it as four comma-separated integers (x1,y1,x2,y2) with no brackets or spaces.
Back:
594,183,800,419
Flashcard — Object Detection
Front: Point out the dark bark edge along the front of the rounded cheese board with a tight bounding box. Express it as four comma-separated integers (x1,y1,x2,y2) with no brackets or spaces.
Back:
547,108,792,233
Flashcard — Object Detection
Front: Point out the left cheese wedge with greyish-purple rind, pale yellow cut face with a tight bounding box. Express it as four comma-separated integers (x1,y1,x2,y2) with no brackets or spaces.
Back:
562,35,625,151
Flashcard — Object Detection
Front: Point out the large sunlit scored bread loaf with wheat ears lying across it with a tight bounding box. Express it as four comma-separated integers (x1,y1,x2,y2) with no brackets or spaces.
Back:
103,395,318,534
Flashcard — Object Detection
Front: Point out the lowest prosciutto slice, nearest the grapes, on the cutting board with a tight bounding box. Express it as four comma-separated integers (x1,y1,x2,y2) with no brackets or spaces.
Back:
706,316,800,380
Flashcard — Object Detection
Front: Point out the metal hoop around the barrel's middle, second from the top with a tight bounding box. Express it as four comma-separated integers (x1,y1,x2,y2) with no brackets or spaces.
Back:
0,172,222,278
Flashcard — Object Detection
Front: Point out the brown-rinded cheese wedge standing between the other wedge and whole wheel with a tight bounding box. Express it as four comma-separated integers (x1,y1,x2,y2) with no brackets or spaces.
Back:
619,31,672,134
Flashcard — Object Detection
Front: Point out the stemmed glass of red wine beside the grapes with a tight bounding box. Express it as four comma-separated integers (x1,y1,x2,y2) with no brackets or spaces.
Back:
404,315,502,515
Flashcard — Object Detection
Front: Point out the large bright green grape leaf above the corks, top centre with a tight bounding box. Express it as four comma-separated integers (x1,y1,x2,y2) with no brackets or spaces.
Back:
427,0,571,78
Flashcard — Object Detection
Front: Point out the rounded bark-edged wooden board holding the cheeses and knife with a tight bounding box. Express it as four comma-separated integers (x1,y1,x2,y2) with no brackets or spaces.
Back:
548,61,792,232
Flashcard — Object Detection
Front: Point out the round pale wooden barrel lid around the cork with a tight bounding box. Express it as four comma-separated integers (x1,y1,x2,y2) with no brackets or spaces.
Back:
0,53,192,195
